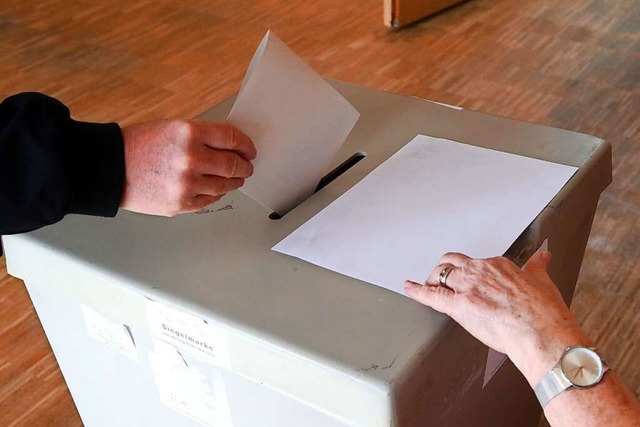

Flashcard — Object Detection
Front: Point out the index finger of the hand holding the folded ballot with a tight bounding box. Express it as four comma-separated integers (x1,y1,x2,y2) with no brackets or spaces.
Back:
194,120,257,160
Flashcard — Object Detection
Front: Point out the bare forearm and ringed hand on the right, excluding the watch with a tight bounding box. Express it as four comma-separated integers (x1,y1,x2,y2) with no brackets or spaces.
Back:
405,252,640,427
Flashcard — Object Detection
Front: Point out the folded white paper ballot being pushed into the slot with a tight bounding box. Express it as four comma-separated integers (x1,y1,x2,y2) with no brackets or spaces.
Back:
227,32,360,215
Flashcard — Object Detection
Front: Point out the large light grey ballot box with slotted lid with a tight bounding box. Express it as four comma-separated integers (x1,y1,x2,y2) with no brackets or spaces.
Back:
4,82,611,427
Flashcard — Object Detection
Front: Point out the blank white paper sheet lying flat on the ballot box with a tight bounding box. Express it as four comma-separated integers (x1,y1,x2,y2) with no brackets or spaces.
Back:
273,135,577,294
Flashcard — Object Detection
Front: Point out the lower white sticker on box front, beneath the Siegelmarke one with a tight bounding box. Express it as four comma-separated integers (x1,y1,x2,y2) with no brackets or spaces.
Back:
149,343,233,427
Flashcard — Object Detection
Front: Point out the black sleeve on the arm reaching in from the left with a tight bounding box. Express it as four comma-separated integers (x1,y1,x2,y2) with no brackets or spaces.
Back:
0,93,124,235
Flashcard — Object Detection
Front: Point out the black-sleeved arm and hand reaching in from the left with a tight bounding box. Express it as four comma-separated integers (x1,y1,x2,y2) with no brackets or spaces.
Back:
0,93,256,234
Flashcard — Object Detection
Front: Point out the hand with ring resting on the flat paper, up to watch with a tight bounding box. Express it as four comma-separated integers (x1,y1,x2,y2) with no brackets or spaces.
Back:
405,252,590,385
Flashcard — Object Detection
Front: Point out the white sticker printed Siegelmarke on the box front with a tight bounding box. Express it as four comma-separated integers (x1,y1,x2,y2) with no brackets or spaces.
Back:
145,299,231,370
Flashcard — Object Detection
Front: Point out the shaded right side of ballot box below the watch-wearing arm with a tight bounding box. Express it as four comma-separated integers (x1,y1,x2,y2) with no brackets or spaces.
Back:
394,321,542,427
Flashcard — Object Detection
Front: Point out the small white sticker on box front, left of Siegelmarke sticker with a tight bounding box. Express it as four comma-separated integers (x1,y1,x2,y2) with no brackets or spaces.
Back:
81,305,138,360
